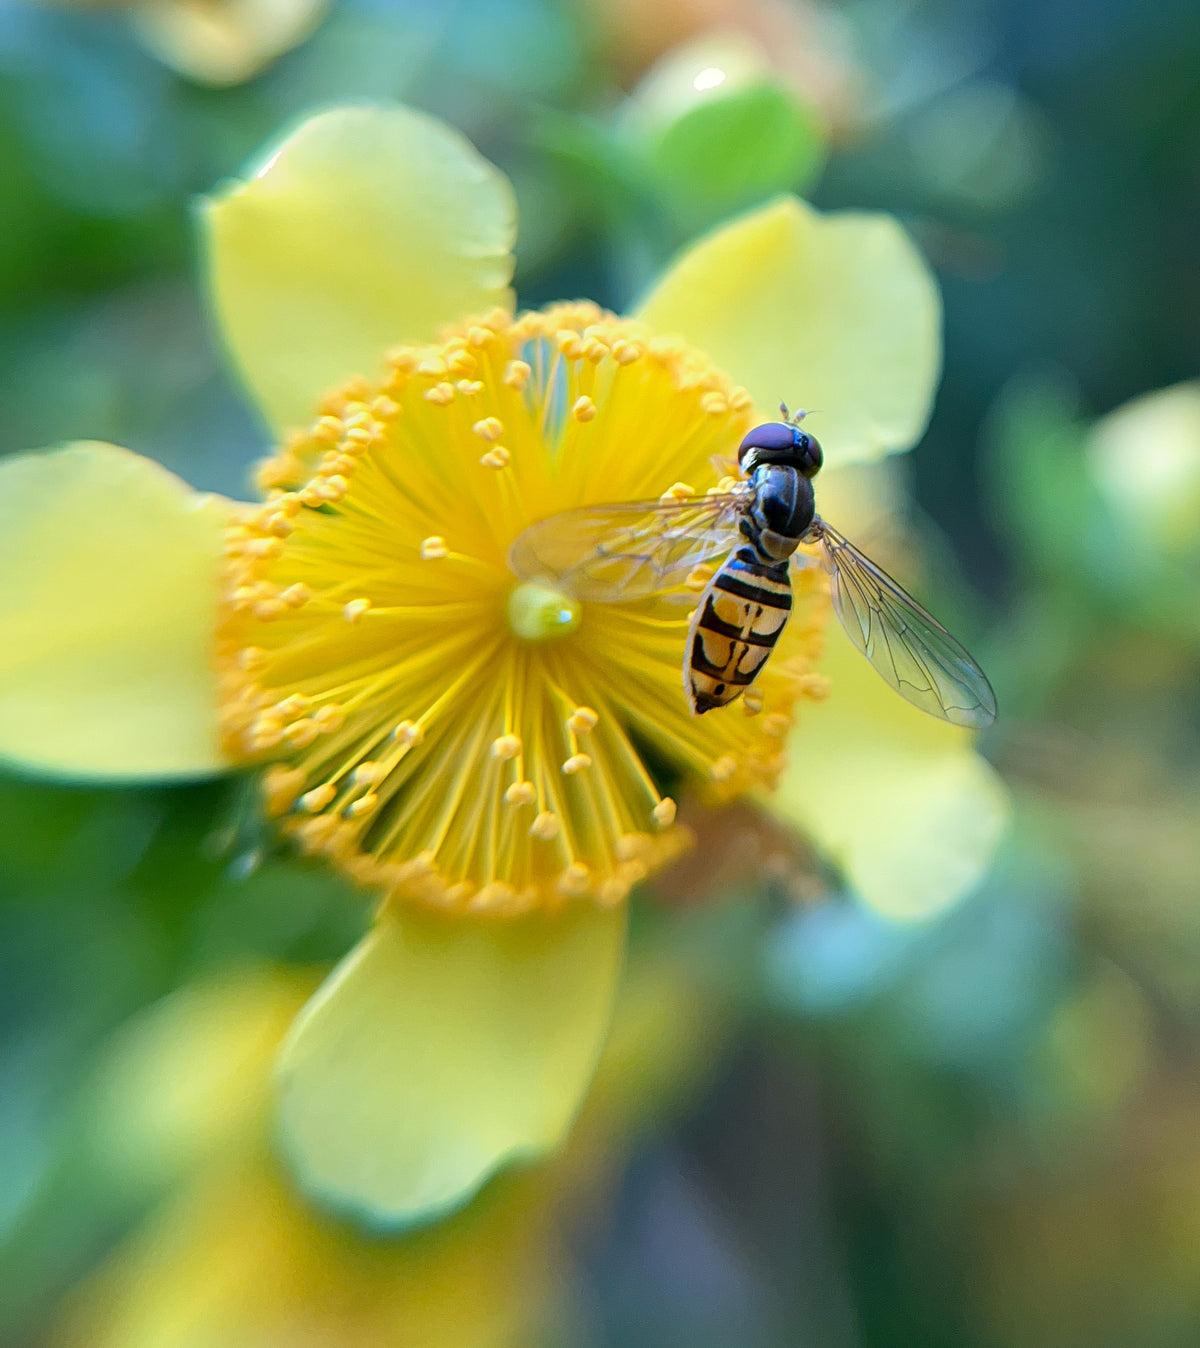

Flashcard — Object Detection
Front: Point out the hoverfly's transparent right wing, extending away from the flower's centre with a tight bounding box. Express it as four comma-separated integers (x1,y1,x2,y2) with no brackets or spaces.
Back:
808,518,996,729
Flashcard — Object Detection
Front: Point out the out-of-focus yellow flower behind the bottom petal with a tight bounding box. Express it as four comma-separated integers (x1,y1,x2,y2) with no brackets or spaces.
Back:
51,950,727,1348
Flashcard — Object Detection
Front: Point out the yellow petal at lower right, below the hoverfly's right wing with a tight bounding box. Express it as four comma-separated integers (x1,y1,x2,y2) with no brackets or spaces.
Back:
774,624,1009,921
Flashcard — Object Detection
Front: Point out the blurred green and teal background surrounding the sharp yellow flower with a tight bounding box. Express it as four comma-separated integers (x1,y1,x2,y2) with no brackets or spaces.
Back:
0,0,1200,1348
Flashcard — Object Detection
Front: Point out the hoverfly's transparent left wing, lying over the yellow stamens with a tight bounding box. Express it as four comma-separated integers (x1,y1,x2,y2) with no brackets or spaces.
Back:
508,491,746,604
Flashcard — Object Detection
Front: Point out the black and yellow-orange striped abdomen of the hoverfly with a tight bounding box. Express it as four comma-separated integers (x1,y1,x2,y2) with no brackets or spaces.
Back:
684,545,791,716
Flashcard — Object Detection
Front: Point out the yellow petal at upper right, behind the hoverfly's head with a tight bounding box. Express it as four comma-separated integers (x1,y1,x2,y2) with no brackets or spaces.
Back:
638,197,941,466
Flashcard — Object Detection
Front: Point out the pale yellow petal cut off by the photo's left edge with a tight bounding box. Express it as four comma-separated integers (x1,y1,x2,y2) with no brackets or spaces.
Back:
0,442,225,780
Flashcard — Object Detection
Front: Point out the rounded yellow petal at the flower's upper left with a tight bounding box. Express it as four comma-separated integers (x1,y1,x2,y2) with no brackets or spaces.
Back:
201,105,516,431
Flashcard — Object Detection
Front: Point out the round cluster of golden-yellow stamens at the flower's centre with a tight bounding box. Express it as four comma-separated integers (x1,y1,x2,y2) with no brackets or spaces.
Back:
217,303,828,921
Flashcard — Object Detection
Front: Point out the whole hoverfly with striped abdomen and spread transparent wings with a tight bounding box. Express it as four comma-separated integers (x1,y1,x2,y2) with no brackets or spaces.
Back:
508,406,996,728
